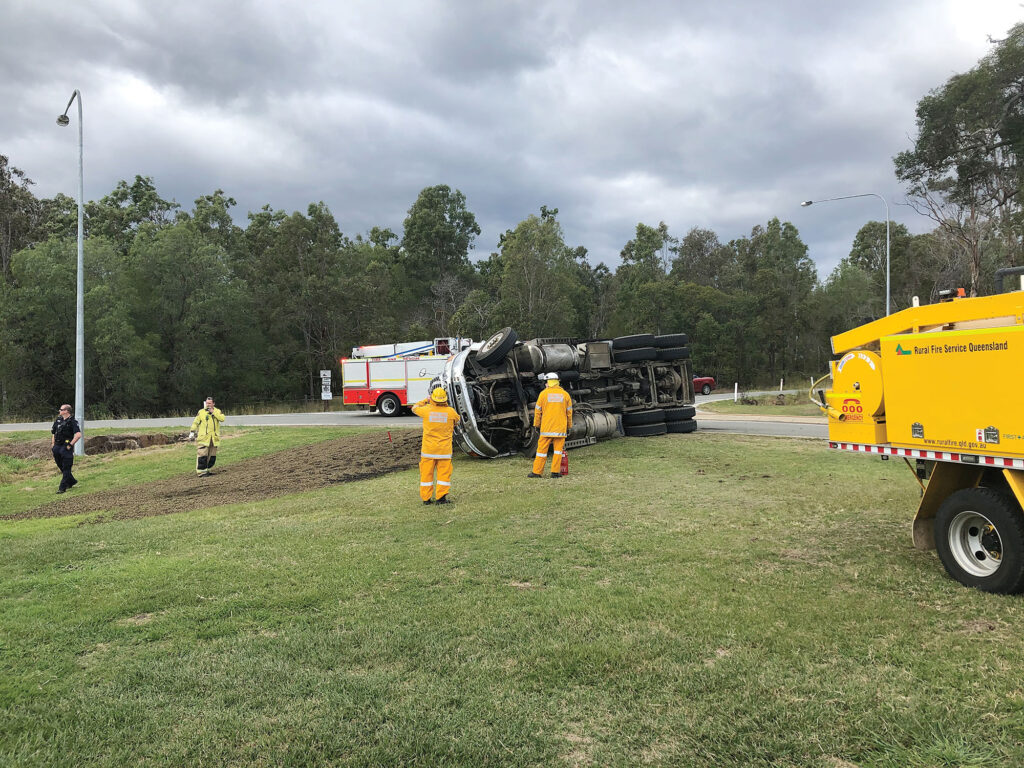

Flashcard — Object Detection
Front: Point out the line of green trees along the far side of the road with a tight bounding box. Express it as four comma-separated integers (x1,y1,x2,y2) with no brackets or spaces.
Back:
0,25,1024,420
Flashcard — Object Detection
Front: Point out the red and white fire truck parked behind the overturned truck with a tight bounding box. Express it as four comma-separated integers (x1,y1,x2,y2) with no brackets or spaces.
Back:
339,337,473,416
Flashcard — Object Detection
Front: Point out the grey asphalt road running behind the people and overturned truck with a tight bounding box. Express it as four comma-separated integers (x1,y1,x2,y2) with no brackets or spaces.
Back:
0,394,828,439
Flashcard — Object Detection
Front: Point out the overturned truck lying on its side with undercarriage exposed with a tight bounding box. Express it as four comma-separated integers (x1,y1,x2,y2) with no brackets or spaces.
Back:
436,328,696,458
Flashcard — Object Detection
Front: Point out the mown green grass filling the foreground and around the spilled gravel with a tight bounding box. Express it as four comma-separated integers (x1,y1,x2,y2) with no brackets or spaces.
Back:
0,429,1024,768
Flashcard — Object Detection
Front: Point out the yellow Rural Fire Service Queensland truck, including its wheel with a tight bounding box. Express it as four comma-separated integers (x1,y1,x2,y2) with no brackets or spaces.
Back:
811,292,1024,593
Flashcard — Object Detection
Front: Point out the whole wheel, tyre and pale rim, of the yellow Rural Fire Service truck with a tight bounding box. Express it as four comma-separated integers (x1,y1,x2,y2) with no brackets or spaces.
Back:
935,487,1024,595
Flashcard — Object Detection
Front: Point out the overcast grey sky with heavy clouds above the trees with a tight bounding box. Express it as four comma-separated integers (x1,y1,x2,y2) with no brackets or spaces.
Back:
0,0,1024,278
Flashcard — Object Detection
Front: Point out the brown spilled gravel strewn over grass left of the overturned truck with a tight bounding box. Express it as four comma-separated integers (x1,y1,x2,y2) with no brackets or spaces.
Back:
0,429,420,522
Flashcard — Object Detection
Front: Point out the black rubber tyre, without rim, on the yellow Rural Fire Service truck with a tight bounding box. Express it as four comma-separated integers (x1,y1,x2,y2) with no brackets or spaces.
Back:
935,487,1024,595
